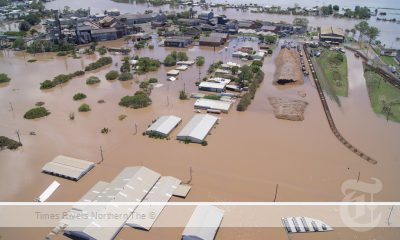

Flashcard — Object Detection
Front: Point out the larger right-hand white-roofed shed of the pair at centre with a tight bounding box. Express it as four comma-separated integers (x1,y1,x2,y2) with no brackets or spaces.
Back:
176,114,218,143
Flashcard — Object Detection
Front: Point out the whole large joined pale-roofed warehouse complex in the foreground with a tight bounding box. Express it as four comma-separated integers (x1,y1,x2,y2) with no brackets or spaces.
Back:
60,166,191,240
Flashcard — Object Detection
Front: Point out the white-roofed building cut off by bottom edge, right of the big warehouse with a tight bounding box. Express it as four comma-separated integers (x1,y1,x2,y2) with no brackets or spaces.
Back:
182,206,224,240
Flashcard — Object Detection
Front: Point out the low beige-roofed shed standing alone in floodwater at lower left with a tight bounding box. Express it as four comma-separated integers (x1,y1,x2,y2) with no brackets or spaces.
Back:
42,155,94,181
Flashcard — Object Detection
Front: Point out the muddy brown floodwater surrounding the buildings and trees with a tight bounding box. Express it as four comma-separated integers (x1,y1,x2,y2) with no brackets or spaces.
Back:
0,32,400,239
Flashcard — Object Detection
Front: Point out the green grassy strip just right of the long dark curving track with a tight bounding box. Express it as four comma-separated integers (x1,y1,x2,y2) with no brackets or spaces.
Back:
315,50,349,97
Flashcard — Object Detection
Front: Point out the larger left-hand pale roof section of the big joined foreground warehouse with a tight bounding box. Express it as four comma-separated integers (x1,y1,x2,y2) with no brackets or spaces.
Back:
64,167,160,240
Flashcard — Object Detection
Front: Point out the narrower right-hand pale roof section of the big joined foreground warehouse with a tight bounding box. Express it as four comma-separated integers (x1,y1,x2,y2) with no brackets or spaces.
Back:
126,176,181,230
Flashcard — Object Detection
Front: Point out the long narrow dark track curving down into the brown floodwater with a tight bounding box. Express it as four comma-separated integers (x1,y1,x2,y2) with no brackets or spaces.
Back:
303,44,378,164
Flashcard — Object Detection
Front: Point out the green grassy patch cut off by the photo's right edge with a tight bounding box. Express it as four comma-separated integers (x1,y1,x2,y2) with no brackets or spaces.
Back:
364,65,400,122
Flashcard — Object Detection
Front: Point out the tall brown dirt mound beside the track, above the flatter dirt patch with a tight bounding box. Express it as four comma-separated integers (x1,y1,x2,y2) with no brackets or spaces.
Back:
274,48,304,85
